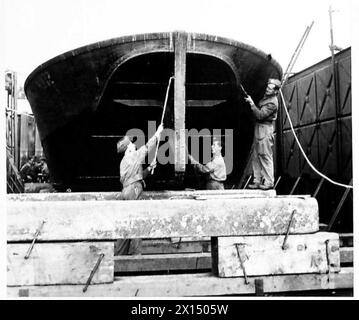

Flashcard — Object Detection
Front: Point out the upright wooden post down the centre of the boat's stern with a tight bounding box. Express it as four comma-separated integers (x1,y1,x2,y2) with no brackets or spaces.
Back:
173,32,187,173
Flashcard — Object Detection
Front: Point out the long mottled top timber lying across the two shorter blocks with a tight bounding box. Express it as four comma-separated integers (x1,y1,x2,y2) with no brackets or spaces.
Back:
7,197,319,242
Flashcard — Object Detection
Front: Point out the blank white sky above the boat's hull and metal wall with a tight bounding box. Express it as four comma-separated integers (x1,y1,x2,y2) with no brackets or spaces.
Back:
0,0,359,296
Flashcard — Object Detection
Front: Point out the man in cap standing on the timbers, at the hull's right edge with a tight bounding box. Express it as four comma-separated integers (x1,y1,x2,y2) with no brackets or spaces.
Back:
245,79,281,190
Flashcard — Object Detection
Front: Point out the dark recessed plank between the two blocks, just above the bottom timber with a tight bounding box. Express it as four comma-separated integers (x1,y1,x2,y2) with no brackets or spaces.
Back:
114,253,211,272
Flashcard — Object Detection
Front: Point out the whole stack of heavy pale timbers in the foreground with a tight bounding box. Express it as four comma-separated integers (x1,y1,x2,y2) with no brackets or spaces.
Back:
7,191,353,297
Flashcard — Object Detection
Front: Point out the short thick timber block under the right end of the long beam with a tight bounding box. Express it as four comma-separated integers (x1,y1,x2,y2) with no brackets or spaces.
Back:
212,232,340,277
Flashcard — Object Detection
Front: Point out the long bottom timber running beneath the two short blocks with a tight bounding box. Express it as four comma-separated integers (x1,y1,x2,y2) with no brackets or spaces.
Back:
7,268,354,297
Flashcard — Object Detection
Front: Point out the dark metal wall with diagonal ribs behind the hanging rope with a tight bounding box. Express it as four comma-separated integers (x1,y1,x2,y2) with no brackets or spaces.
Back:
276,48,352,230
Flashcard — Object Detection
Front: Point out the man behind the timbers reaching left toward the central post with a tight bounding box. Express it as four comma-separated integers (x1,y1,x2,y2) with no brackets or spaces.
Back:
188,140,227,190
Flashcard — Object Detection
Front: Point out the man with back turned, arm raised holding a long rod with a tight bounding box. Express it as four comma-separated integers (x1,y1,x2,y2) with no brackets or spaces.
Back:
115,124,163,255
